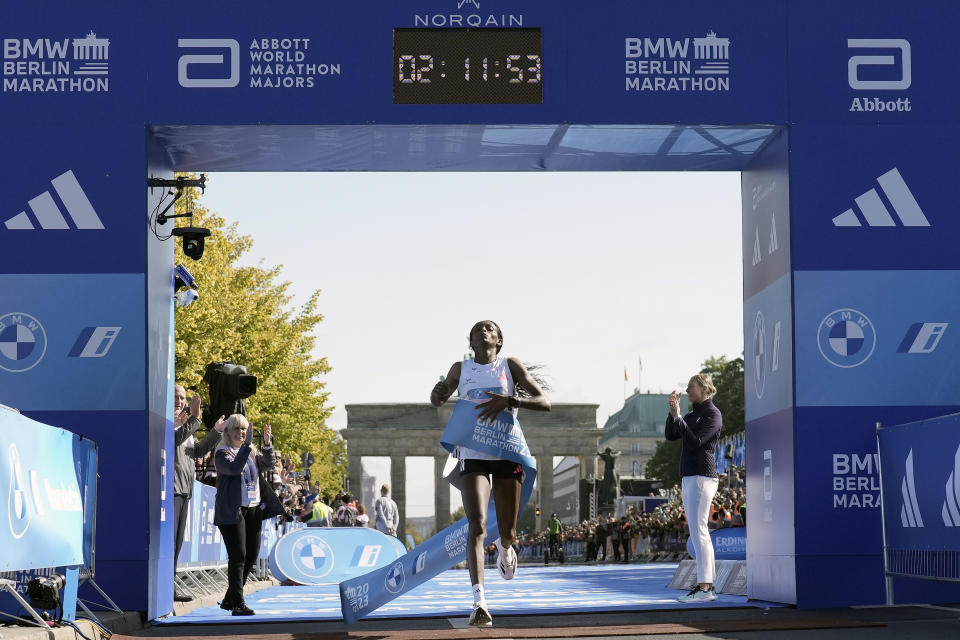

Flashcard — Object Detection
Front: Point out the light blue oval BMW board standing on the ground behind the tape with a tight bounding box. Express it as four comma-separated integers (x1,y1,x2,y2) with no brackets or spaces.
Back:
270,527,406,584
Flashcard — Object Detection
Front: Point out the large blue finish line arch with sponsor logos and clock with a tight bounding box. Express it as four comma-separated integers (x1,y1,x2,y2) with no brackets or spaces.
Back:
0,0,960,617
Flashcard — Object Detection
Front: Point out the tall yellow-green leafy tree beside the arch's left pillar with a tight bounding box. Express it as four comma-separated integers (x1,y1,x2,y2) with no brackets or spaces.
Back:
174,175,347,492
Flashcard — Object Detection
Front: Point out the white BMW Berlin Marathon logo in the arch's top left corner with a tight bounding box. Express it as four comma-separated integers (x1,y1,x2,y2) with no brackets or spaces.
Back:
3,31,110,93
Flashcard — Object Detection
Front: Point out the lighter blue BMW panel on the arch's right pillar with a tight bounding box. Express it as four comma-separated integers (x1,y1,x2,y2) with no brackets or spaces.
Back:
794,271,960,406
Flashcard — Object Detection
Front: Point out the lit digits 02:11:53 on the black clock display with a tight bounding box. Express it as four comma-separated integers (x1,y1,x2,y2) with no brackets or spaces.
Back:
397,53,543,84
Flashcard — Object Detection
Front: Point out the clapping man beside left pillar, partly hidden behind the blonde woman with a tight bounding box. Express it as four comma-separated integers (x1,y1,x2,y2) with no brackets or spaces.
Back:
173,384,220,602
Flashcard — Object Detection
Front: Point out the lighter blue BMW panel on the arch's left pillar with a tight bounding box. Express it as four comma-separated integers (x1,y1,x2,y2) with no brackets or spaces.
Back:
0,274,145,411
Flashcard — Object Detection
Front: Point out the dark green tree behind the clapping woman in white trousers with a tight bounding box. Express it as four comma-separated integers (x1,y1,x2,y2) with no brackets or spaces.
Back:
645,356,745,486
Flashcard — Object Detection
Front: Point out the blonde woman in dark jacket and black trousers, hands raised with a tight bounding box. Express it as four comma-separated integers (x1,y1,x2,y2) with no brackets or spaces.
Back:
213,413,274,616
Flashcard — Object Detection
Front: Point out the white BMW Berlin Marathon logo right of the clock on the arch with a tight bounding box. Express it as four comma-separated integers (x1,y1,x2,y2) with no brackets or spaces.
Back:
624,31,730,93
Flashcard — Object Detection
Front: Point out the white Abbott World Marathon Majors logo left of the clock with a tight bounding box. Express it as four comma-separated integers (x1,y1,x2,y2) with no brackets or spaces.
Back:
177,36,341,89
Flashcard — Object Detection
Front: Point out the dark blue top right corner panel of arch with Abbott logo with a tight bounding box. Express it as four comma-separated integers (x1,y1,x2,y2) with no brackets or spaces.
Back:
789,0,960,124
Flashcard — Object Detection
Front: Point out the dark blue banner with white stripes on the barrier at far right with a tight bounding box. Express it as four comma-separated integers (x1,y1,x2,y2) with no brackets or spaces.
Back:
877,414,960,556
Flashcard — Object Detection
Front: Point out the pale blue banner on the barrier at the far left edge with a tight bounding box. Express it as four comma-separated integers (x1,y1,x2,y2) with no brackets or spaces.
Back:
0,407,96,571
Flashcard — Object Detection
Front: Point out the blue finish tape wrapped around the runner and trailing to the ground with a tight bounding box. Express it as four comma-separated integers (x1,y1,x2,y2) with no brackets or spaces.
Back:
340,402,537,624
